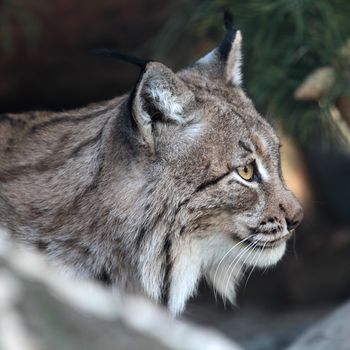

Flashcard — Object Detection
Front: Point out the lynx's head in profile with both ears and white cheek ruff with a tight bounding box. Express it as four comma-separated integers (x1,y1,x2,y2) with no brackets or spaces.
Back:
131,16,303,314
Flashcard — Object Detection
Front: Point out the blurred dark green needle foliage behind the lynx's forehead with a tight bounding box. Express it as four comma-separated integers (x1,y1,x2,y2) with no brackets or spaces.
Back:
157,0,350,146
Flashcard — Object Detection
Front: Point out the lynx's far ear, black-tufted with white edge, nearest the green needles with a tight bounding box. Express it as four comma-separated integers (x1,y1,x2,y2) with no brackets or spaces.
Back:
194,12,242,86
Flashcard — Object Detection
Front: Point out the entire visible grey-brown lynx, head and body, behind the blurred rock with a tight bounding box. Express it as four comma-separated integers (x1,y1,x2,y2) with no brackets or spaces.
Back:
0,15,303,314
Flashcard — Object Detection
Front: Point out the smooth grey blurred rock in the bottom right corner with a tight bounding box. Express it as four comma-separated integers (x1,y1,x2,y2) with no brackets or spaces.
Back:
287,301,350,350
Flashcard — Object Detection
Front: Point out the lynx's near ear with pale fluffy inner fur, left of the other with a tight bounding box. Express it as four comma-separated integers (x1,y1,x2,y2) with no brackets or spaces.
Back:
132,62,194,149
